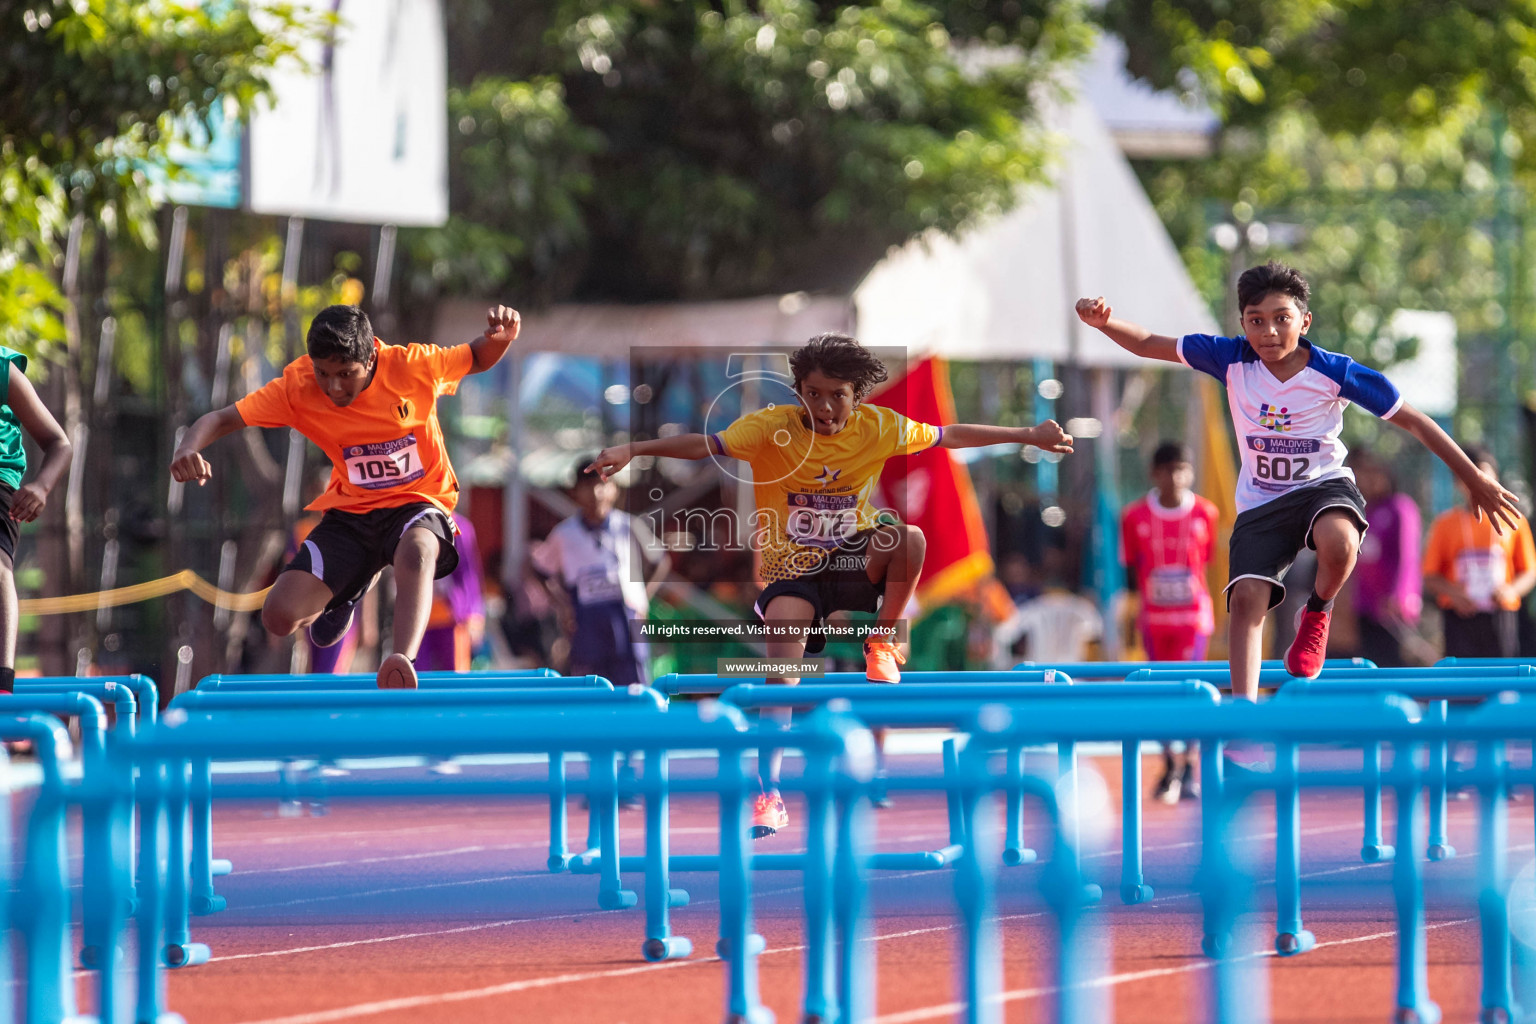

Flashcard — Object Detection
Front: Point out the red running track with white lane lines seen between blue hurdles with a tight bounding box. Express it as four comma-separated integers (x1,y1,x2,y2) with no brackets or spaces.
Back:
62,760,1511,1024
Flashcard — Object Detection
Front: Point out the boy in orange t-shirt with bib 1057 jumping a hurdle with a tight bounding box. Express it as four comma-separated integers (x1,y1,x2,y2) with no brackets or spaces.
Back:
170,306,522,689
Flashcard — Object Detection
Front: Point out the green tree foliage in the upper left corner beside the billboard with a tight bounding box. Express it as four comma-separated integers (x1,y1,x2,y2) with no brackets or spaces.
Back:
0,0,318,352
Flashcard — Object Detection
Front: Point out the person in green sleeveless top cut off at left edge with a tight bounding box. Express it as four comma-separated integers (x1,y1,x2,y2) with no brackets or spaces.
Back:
0,345,71,692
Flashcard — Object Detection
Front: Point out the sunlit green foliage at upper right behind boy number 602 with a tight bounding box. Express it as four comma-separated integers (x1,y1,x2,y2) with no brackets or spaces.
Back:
1103,0,1536,461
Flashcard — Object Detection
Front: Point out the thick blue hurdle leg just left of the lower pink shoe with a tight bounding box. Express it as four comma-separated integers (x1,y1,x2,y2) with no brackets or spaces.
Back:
716,751,774,1024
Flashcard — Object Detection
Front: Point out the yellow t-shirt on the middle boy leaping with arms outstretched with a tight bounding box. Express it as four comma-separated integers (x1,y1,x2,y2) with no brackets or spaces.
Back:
710,405,943,582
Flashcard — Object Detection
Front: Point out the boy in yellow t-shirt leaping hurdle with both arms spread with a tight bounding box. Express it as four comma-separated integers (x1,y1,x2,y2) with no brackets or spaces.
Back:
587,333,1072,838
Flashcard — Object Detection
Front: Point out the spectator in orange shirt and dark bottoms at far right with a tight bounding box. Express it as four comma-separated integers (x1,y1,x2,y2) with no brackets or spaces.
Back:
1424,445,1536,657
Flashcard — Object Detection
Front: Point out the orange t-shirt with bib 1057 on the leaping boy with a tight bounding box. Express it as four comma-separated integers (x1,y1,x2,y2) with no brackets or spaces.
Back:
235,338,475,513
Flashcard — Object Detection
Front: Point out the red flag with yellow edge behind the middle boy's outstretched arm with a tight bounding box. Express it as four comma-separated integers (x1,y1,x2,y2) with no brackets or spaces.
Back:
869,356,992,606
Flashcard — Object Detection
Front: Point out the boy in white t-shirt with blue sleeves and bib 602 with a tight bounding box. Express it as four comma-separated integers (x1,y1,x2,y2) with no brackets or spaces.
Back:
1077,263,1516,700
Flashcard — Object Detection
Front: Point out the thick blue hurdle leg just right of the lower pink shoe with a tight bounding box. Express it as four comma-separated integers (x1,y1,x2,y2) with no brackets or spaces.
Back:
802,754,839,1024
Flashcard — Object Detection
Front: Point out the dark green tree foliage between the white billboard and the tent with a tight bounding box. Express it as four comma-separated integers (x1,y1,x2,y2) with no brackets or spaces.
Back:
413,0,1092,301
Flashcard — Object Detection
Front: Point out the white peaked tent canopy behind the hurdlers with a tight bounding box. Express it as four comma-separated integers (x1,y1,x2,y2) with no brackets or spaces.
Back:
854,90,1217,367
